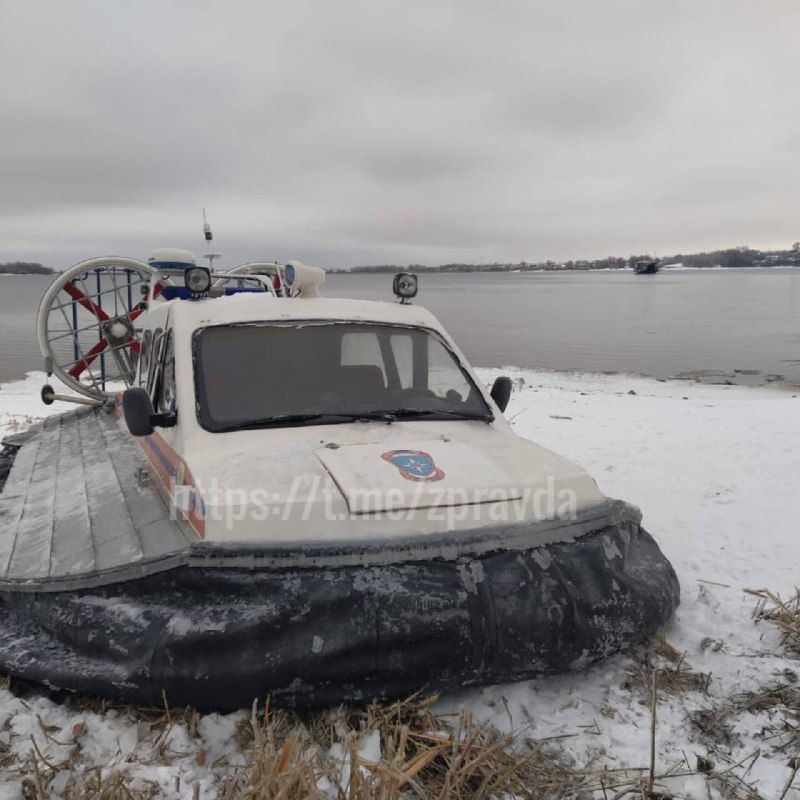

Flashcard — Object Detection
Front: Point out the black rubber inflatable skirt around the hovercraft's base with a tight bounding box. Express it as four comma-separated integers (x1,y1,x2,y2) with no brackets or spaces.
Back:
0,520,680,709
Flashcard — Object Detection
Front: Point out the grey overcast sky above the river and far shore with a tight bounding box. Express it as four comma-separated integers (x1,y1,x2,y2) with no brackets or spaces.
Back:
0,0,800,268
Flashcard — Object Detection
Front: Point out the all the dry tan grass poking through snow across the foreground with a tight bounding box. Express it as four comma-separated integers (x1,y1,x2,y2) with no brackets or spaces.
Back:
6,592,800,800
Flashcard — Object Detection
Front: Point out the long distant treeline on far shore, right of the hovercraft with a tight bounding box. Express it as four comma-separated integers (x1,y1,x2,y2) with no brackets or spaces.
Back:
331,242,800,272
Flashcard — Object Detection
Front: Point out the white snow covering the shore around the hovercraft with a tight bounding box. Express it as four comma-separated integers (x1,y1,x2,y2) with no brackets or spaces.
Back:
0,368,800,799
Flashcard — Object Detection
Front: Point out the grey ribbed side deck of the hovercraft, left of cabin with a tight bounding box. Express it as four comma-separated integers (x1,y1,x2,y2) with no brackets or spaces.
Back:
0,408,194,591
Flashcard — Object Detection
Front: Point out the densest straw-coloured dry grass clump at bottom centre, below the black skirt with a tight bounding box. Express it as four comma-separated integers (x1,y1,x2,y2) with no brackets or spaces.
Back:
223,699,587,800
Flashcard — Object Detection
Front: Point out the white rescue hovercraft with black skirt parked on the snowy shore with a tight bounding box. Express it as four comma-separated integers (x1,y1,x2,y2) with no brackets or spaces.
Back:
0,231,679,709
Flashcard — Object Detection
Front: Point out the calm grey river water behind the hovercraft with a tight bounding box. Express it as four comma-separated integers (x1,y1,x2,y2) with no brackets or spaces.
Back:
0,269,800,384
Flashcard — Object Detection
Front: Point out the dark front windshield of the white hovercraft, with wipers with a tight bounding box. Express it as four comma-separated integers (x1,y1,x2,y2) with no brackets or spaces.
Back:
194,322,492,431
